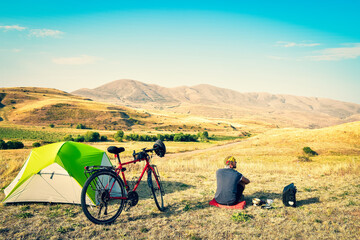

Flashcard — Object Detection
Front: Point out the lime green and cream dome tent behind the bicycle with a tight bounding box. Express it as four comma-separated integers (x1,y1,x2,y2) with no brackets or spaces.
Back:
3,142,111,204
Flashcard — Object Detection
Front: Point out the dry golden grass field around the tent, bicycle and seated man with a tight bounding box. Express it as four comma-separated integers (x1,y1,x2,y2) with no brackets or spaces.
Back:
0,122,360,239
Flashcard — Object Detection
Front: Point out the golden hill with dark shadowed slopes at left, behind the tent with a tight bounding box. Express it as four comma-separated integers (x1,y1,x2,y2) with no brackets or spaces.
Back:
0,88,149,130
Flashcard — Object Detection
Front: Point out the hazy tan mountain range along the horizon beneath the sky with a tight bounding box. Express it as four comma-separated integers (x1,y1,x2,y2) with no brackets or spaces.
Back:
72,79,360,128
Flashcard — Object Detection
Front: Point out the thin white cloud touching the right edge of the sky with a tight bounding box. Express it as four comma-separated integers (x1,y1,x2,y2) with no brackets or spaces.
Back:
306,43,360,61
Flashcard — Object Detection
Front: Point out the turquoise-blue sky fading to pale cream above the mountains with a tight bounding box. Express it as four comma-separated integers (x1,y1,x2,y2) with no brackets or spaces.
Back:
0,0,360,103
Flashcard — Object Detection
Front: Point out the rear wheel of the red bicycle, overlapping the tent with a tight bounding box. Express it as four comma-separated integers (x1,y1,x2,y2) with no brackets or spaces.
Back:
81,171,126,224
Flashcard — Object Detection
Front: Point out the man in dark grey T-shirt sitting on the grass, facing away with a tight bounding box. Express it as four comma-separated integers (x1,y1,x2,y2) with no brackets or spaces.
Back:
215,156,250,205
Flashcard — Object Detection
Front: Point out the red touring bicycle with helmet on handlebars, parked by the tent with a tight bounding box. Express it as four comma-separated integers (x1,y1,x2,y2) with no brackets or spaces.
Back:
81,140,166,224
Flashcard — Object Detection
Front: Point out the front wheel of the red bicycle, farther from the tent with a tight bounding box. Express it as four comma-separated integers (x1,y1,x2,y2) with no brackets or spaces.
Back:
148,166,165,212
